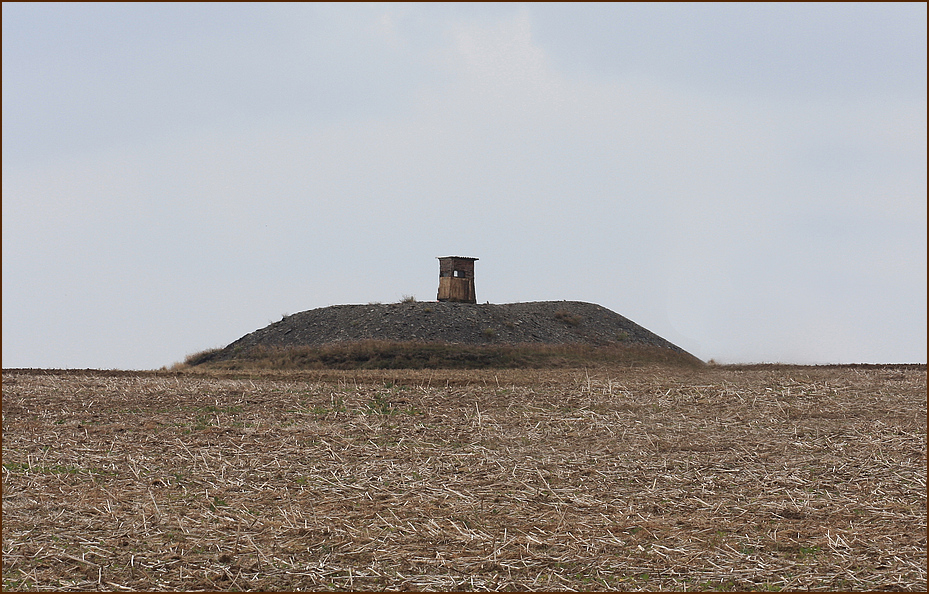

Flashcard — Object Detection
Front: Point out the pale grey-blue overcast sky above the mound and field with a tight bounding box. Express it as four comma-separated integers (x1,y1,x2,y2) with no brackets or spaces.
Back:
2,3,927,369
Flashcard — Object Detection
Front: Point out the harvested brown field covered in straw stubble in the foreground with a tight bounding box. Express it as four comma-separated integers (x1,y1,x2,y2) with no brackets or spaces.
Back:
3,365,926,590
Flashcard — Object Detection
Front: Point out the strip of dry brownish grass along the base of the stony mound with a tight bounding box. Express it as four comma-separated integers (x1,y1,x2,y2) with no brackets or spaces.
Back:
185,340,703,370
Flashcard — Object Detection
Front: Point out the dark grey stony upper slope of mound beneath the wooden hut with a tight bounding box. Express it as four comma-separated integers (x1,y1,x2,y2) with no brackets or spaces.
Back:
203,301,692,361
